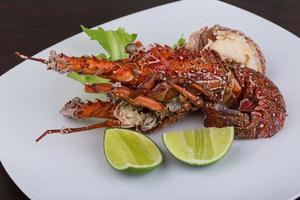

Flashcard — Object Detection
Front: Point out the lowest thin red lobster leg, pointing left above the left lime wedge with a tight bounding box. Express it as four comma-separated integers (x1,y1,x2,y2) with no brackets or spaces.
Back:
35,119,118,142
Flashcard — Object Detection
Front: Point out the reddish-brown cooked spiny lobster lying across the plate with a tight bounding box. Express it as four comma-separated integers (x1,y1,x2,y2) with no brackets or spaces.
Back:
16,25,286,141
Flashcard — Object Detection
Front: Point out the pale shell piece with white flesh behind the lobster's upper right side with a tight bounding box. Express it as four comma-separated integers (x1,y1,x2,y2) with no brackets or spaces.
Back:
187,25,266,74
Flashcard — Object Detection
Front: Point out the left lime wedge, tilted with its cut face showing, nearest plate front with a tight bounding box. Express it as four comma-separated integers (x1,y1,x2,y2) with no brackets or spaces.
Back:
104,128,162,173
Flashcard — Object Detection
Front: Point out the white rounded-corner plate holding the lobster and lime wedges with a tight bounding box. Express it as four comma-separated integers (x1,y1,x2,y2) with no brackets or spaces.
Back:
0,0,300,200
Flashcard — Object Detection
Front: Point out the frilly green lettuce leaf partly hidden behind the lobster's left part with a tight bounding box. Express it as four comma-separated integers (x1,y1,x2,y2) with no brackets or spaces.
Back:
67,26,137,85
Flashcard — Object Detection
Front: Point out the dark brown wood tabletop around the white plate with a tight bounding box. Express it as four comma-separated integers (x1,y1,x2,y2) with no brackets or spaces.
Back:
0,0,300,200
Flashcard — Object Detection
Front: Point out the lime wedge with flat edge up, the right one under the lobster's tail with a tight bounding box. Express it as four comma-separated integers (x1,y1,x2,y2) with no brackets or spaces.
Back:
163,127,234,166
